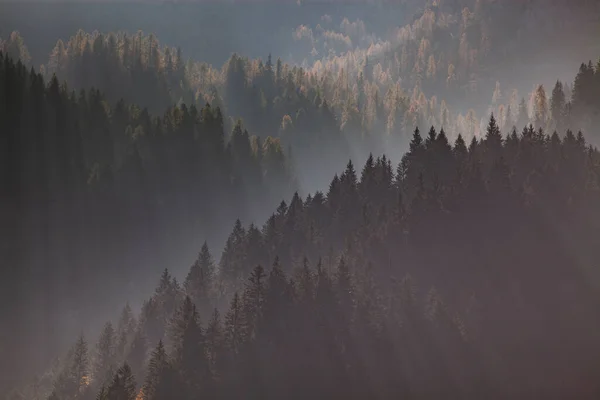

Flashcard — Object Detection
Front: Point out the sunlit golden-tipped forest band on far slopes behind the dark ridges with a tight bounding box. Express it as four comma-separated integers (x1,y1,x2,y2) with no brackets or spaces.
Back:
4,0,595,189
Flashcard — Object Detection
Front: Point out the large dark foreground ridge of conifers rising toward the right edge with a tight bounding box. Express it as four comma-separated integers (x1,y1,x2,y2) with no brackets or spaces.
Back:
34,116,600,399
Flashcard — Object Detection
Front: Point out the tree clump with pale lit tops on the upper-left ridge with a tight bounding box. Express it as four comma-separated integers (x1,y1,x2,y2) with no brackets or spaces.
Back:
45,30,193,113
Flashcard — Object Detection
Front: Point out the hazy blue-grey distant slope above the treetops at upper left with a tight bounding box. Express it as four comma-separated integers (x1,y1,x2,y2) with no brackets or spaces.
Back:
0,0,425,65
